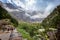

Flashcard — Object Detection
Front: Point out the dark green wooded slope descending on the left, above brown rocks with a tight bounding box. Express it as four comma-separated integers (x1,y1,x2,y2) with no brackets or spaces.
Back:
0,6,18,27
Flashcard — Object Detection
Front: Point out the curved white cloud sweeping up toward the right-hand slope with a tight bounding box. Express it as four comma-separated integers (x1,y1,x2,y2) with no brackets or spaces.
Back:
26,4,54,19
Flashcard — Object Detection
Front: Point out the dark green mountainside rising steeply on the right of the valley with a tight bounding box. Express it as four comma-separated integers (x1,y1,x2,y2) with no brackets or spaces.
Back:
42,5,60,27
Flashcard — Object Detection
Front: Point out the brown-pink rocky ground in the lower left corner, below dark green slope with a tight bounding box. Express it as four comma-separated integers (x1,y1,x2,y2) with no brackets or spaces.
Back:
0,19,22,40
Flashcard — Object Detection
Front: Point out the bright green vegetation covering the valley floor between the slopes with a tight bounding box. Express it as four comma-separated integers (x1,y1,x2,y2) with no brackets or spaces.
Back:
17,22,47,40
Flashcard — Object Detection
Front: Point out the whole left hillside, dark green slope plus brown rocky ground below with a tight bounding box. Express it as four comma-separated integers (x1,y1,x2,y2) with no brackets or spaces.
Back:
0,5,22,40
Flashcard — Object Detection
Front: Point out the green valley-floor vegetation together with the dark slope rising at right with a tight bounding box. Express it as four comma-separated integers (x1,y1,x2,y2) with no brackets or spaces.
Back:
17,6,60,40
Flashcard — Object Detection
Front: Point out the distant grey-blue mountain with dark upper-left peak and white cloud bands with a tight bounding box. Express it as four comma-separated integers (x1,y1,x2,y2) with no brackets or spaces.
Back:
2,3,44,22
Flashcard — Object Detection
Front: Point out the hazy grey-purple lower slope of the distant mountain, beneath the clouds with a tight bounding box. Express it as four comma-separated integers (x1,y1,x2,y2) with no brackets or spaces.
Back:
11,11,44,22
